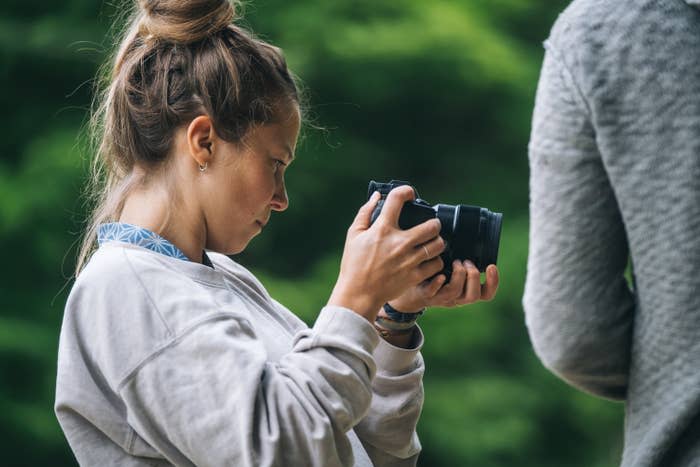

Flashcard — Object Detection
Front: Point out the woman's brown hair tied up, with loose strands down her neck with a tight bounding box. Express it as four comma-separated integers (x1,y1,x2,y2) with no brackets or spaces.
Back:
75,0,301,276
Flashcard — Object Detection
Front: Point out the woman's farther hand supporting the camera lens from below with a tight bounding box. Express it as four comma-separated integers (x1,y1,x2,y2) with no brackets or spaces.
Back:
389,260,498,313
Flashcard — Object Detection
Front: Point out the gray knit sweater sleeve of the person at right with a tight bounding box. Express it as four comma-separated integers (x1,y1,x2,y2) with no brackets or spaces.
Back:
523,43,634,399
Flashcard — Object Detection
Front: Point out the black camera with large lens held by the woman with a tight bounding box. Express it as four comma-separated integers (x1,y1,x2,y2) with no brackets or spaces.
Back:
367,180,503,281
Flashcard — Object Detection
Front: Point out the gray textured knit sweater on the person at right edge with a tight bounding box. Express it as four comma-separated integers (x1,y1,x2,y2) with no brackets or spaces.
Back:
524,0,700,467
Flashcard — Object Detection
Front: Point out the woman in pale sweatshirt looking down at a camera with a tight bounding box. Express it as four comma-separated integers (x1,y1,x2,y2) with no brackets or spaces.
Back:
56,0,498,466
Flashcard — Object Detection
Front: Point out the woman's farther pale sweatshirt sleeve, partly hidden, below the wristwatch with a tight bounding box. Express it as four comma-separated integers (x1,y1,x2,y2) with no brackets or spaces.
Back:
355,327,425,467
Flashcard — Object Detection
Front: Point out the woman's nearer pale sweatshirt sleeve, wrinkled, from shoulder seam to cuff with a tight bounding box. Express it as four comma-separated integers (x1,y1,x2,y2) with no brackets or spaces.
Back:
119,307,379,466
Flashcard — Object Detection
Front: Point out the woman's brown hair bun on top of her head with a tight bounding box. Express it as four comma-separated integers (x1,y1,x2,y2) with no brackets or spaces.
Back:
139,0,236,44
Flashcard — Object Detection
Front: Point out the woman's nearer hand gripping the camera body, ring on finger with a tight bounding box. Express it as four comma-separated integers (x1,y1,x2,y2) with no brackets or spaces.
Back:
328,186,445,322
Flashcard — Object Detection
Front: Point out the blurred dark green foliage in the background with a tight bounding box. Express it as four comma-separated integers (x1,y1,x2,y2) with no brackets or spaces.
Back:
0,0,622,467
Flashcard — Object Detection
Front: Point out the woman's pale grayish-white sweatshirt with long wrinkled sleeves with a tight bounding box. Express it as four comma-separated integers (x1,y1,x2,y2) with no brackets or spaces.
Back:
55,242,424,466
